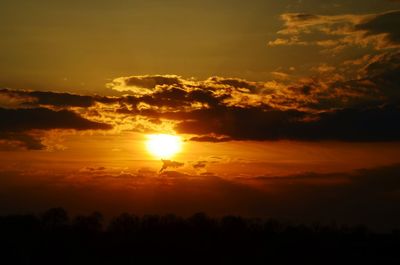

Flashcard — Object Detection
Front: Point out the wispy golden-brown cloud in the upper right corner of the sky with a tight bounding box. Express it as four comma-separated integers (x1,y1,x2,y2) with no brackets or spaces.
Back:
269,10,400,51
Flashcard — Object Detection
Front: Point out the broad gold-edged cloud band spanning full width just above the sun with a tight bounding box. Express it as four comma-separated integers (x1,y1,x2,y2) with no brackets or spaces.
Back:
0,47,400,146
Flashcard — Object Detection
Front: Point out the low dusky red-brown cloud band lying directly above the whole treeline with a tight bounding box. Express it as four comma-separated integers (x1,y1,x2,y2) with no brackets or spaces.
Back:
0,164,400,230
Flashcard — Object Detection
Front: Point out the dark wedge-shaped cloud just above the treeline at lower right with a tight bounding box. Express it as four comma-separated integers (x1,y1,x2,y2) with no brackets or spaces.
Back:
239,164,400,229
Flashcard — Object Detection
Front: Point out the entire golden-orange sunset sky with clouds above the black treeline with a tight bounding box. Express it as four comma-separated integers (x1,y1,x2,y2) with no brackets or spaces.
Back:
0,0,400,227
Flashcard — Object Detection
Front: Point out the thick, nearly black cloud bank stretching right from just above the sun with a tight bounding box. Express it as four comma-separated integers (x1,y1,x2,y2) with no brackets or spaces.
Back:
172,105,400,141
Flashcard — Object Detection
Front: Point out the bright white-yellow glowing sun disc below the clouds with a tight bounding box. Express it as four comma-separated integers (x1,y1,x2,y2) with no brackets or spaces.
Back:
146,134,182,159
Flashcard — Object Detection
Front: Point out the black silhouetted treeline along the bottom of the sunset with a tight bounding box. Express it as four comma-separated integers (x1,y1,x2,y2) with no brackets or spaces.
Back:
0,208,400,265
